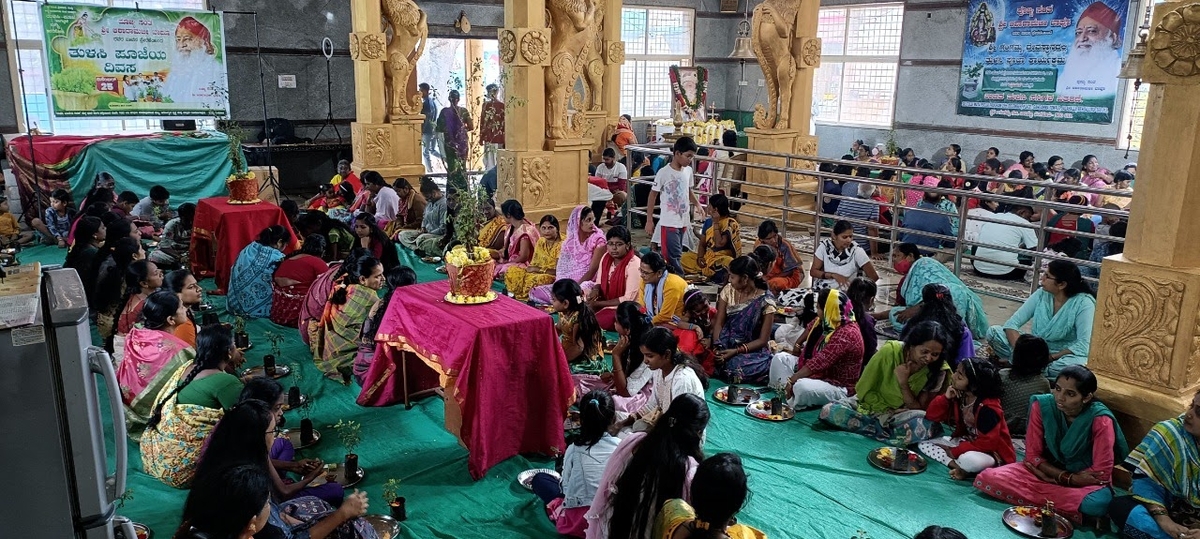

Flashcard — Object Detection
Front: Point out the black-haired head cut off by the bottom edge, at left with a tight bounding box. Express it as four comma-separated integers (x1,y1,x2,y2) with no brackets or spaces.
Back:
170,463,271,539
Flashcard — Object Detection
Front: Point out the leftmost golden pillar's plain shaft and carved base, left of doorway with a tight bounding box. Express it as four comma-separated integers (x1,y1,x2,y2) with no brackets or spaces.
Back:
350,0,425,180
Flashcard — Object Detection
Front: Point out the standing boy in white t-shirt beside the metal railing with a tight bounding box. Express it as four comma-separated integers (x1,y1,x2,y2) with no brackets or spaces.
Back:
646,137,698,275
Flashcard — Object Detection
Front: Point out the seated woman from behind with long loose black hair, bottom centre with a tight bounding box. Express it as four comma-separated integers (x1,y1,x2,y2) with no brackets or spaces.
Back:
587,391,709,539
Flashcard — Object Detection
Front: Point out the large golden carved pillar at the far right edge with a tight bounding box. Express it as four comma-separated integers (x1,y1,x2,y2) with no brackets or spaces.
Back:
1088,1,1200,443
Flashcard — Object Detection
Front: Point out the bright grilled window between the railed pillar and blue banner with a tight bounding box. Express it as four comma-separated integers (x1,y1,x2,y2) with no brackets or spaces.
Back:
812,4,904,127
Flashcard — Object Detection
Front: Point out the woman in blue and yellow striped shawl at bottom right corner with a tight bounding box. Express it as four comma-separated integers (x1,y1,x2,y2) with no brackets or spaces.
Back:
1112,388,1200,539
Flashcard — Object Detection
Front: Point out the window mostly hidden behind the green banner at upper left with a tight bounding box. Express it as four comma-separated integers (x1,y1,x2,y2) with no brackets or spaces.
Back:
2,0,216,134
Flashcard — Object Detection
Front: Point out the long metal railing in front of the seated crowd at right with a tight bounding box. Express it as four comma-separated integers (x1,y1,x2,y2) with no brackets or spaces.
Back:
625,144,1133,301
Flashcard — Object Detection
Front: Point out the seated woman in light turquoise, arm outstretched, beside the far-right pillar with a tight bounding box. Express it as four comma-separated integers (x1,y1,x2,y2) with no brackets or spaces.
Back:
988,259,1096,379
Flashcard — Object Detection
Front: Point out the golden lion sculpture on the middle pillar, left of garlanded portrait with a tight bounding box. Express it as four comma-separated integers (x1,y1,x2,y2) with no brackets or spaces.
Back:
546,0,604,140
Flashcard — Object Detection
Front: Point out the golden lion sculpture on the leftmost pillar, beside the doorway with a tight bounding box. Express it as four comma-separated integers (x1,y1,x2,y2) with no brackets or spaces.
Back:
383,0,430,118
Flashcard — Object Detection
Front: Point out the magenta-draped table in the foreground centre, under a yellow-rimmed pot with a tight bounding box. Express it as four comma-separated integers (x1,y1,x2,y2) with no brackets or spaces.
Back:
360,281,575,479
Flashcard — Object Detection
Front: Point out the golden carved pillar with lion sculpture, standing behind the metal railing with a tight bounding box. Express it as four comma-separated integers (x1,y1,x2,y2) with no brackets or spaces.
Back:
739,0,821,224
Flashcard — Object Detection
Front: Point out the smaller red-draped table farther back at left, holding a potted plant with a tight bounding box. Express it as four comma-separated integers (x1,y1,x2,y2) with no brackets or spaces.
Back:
191,197,298,294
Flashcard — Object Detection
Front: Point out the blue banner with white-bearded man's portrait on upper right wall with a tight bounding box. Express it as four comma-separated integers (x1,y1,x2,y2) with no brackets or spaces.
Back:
958,0,1128,124
